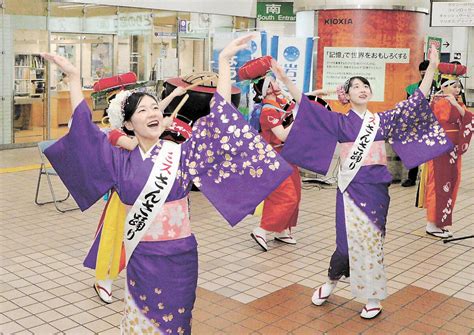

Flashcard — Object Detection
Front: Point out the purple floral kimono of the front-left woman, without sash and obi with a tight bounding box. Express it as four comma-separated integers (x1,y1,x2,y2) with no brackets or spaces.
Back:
45,94,292,335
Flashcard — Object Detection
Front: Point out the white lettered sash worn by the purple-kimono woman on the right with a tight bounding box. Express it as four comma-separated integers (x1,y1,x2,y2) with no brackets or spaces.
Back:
337,111,380,193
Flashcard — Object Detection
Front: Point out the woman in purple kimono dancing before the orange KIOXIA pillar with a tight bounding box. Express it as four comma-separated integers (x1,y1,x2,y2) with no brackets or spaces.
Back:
274,48,452,319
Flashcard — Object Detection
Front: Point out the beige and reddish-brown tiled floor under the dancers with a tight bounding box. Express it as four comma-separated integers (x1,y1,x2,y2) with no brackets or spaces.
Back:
0,148,474,335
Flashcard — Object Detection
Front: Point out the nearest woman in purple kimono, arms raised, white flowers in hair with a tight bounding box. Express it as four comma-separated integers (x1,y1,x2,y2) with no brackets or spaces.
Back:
44,35,292,335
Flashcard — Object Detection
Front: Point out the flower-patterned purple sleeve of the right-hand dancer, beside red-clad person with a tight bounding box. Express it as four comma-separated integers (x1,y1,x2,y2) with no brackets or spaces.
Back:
379,89,453,169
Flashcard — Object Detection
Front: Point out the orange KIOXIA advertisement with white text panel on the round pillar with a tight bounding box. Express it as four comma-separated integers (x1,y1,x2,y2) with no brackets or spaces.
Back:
315,9,426,111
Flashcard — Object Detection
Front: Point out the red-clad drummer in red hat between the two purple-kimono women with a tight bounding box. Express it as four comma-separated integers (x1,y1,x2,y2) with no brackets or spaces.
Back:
239,56,301,251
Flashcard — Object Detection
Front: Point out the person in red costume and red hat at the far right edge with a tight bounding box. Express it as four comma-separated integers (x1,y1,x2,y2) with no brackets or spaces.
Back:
417,63,474,239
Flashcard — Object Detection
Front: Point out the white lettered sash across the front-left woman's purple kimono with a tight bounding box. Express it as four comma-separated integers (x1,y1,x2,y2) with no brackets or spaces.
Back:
123,141,181,263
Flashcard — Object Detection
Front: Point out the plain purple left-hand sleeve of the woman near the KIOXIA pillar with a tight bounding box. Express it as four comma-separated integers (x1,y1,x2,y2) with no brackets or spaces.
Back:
281,95,340,174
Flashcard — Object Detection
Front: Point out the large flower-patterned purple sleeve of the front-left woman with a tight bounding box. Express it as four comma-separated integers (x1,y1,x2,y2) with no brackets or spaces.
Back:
185,93,292,226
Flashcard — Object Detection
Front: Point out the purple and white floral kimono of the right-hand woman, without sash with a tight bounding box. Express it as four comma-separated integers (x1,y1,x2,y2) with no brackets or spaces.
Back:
281,90,452,299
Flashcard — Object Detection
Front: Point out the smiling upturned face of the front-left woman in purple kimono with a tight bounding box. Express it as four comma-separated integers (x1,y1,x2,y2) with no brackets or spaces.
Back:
124,95,163,148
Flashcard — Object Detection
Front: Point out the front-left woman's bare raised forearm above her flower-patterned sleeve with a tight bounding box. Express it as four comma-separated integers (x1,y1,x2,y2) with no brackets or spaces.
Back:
216,34,256,102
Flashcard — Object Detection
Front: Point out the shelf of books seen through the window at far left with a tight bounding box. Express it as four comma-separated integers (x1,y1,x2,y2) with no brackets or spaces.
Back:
13,54,46,98
